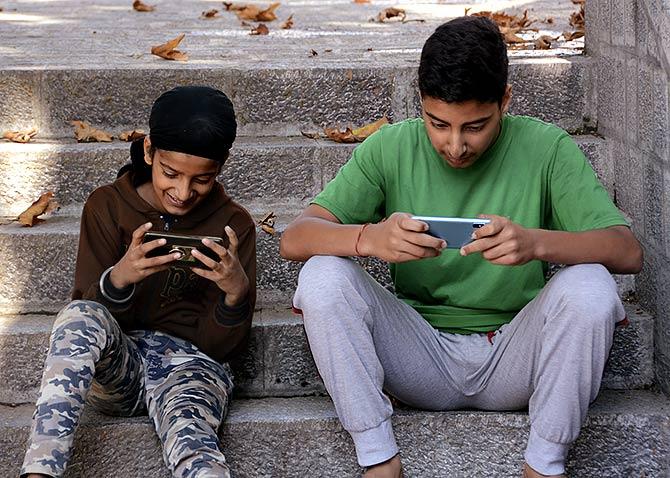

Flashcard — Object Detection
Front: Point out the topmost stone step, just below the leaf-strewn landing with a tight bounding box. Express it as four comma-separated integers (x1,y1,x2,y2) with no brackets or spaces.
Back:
0,56,590,138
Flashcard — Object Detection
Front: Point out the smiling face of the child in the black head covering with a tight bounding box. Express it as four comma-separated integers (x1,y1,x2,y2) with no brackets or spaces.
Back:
138,137,221,216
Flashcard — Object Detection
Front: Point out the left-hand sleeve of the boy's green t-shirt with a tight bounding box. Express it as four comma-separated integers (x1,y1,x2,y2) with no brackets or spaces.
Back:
312,129,385,224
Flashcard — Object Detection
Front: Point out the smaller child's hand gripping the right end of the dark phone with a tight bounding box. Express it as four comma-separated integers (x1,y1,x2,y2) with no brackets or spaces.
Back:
191,226,249,307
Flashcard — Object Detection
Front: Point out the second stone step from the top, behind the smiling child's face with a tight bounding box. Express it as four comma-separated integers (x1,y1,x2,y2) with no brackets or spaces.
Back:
0,135,614,217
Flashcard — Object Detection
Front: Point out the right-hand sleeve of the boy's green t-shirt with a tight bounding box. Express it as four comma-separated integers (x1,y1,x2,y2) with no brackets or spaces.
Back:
549,134,629,232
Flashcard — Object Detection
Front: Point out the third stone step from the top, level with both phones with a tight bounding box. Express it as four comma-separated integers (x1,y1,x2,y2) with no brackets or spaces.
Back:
0,210,635,315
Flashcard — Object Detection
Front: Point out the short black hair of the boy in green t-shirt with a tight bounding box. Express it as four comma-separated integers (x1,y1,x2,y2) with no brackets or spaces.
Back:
419,16,508,104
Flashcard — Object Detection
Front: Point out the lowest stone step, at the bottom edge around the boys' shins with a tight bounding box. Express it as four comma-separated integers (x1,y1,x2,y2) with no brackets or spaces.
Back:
0,391,670,478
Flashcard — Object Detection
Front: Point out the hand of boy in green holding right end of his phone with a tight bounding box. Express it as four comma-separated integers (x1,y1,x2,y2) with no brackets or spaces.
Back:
461,214,537,266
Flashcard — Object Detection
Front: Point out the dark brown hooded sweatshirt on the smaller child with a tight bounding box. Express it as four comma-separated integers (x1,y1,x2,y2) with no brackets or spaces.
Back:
72,173,256,362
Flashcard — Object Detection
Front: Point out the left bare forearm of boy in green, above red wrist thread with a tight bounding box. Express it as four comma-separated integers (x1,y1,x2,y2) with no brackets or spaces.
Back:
279,216,362,261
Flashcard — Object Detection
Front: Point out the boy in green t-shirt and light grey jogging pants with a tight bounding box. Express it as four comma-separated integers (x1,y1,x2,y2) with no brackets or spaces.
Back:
281,17,642,478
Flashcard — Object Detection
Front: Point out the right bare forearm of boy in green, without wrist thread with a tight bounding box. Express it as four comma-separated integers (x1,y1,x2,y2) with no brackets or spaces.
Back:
532,226,642,274
